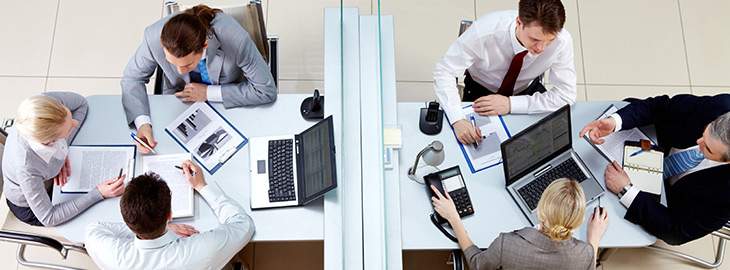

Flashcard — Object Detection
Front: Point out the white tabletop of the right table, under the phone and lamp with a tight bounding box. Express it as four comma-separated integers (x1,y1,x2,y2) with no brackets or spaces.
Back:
394,102,665,250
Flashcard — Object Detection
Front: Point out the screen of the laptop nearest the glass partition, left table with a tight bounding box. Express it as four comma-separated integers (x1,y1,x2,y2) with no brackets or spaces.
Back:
298,116,337,202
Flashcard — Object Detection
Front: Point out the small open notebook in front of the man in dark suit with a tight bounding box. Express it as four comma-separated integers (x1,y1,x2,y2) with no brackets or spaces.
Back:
623,142,664,196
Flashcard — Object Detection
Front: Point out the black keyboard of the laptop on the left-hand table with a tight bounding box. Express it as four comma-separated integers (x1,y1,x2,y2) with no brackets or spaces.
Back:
269,139,296,202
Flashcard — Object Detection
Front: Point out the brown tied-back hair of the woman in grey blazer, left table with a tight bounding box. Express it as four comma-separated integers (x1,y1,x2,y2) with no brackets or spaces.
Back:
160,5,221,57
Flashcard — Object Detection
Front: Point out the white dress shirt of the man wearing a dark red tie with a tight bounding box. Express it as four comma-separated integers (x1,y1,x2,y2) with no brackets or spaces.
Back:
434,10,576,124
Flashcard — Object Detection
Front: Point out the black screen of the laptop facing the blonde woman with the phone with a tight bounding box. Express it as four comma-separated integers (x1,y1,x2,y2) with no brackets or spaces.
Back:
502,105,572,186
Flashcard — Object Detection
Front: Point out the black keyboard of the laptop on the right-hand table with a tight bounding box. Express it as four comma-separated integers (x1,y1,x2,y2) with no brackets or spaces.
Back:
517,158,588,210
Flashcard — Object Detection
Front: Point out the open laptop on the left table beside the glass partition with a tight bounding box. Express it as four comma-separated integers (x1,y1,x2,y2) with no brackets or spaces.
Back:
249,116,337,210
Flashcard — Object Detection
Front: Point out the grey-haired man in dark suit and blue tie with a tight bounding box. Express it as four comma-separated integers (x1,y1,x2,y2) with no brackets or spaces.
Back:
580,94,730,245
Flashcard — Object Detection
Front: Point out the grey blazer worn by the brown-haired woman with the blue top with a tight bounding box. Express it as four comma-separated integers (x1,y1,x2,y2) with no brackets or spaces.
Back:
121,12,277,124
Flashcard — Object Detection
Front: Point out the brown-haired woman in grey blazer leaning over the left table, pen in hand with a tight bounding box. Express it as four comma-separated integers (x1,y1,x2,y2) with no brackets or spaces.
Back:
121,5,277,153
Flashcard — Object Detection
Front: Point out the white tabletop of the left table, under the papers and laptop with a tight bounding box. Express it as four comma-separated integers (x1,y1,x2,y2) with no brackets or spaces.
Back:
53,94,324,242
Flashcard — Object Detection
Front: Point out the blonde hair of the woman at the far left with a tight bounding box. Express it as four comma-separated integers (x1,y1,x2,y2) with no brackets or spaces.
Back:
15,95,68,143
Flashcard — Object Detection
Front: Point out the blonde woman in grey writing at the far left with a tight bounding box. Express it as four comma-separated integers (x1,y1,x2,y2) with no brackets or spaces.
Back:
2,92,124,226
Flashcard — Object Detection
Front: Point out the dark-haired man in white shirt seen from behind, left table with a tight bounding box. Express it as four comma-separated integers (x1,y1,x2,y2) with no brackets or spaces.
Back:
86,161,254,270
